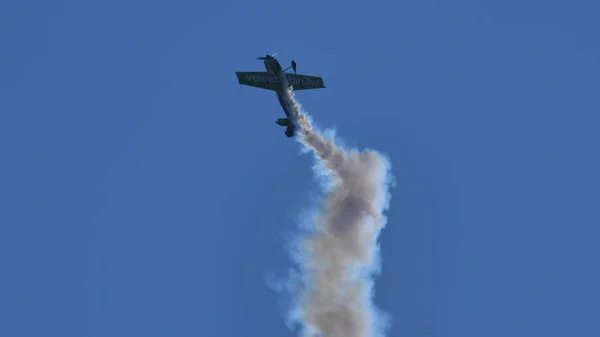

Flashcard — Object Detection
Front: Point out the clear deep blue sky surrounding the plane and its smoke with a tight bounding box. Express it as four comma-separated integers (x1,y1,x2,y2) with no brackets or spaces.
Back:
0,0,600,337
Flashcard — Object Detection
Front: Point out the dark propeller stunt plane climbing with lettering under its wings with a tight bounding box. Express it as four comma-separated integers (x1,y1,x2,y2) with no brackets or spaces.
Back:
235,54,325,138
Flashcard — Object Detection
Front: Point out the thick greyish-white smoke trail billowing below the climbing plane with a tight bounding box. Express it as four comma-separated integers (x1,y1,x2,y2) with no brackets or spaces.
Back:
287,90,392,337
